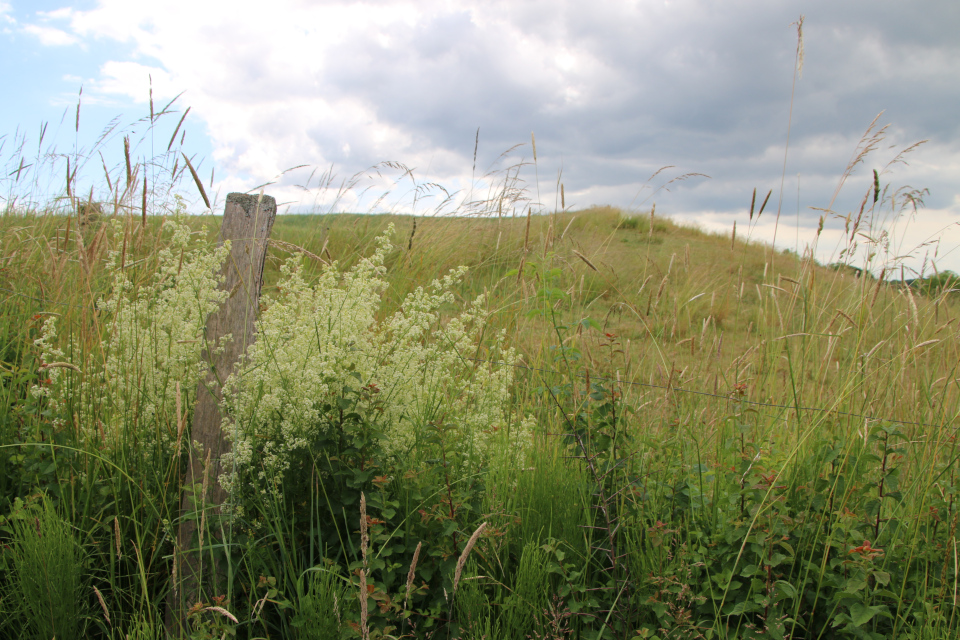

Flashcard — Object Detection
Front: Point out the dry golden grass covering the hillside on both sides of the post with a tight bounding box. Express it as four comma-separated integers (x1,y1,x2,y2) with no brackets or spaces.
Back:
0,198,960,482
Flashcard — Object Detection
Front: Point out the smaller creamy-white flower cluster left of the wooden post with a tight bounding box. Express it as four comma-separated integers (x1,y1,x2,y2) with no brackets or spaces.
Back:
37,220,230,446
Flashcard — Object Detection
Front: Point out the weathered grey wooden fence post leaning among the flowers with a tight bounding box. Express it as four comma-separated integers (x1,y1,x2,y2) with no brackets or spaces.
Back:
166,193,277,637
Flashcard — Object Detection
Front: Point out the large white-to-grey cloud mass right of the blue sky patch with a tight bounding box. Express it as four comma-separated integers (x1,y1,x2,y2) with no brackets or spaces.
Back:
30,0,960,270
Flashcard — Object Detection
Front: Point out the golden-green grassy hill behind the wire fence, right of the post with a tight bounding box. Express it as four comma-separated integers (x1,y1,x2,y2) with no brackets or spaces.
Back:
264,207,960,436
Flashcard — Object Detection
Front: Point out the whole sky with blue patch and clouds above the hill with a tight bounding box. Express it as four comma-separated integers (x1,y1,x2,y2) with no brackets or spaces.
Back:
0,0,960,272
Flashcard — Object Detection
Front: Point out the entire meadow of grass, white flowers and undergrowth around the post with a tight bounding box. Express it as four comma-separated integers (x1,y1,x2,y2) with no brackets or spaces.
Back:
0,114,960,640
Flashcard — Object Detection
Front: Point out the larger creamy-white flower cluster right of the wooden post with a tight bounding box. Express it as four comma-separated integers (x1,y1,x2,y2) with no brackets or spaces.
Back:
221,226,530,491
